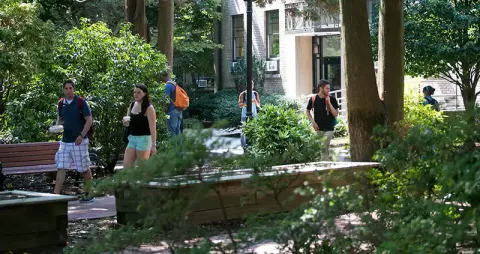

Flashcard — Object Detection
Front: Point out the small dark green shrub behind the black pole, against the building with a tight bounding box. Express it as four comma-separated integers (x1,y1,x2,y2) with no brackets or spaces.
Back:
231,56,266,92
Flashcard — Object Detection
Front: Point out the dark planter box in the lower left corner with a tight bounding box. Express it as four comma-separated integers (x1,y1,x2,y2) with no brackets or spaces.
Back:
0,191,76,253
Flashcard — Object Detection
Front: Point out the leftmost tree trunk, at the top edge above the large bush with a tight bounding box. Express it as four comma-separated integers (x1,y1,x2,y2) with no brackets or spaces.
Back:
125,0,150,42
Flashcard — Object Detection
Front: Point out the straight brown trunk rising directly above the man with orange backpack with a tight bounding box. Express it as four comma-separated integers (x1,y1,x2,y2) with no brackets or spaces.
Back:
158,0,174,67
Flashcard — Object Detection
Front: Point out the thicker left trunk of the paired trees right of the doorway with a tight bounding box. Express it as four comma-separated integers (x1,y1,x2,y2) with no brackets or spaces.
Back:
340,0,384,161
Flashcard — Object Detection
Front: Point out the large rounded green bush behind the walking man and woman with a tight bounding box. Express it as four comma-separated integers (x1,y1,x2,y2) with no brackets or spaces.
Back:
6,20,168,169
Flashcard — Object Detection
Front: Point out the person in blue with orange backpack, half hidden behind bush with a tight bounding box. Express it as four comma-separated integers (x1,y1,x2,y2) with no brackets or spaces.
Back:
162,72,190,137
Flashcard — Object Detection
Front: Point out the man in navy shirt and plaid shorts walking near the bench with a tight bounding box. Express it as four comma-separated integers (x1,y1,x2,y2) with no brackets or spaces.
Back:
54,80,93,203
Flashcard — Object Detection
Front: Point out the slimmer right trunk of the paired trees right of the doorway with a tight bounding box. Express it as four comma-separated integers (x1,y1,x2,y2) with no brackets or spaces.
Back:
377,0,405,124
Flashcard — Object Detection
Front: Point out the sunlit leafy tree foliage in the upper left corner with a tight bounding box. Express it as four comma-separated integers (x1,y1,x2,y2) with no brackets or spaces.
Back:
0,0,55,115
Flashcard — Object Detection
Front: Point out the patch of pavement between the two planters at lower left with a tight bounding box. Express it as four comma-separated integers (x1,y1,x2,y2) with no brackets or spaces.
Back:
68,196,117,221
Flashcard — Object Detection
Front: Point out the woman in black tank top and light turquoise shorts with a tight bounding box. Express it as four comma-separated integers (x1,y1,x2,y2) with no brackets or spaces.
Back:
123,84,157,168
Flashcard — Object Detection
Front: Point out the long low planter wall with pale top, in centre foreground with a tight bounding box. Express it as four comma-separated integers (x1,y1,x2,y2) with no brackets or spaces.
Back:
115,162,378,224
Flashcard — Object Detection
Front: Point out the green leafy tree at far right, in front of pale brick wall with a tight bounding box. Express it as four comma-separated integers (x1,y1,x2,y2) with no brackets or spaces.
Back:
405,0,480,109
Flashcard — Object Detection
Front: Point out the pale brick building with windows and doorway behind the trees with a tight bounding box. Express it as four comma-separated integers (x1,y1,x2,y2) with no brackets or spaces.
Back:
216,0,480,109
